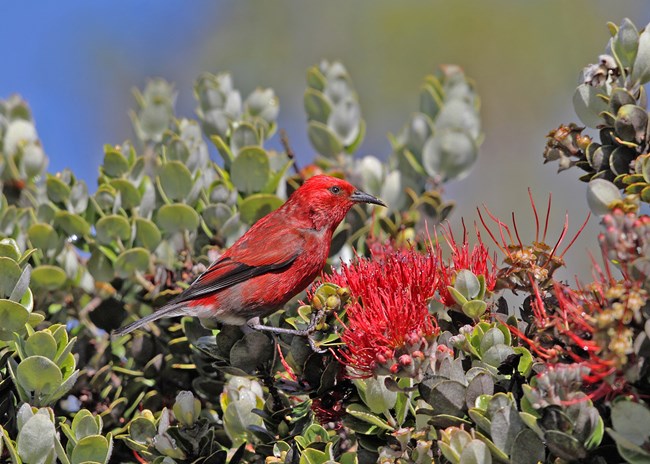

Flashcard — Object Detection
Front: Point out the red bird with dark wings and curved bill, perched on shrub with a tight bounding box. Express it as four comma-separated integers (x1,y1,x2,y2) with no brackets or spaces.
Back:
113,175,386,336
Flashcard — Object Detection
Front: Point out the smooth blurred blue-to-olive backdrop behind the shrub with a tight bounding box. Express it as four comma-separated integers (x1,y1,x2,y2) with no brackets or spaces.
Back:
0,0,650,278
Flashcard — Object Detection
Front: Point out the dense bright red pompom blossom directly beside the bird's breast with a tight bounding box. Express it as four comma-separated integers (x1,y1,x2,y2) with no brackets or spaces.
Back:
325,239,437,377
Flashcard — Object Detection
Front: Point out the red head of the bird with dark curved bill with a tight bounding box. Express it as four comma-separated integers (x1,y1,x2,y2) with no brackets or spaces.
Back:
287,175,386,231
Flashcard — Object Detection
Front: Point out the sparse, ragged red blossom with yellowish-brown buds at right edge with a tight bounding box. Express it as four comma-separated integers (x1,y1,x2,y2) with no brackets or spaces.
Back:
510,269,646,399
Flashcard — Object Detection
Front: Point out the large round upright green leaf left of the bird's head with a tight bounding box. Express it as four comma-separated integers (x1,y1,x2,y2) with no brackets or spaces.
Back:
230,146,271,194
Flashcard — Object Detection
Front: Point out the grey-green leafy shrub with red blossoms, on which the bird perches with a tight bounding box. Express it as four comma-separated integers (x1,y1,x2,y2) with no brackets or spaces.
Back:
0,20,650,464
